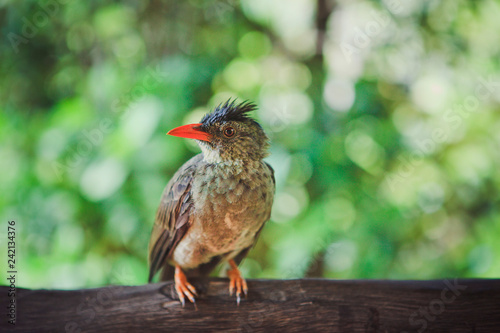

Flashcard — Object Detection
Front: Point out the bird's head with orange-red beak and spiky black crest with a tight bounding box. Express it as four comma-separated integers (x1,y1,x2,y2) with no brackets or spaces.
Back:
167,100,269,162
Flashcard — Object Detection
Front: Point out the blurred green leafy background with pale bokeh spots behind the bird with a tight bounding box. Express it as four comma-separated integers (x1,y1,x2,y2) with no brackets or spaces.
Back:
0,0,500,288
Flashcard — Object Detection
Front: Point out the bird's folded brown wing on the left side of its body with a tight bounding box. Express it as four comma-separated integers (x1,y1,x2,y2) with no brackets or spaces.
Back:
149,154,203,282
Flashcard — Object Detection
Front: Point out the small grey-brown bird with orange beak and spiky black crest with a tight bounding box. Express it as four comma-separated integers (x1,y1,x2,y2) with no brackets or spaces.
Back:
149,100,275,306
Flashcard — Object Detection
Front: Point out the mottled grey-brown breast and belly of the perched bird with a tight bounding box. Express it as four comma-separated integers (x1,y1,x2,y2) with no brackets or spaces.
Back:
174,160,274,267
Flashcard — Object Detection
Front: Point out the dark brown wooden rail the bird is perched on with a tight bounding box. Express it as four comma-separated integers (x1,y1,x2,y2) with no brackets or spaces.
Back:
0,279,500,332
